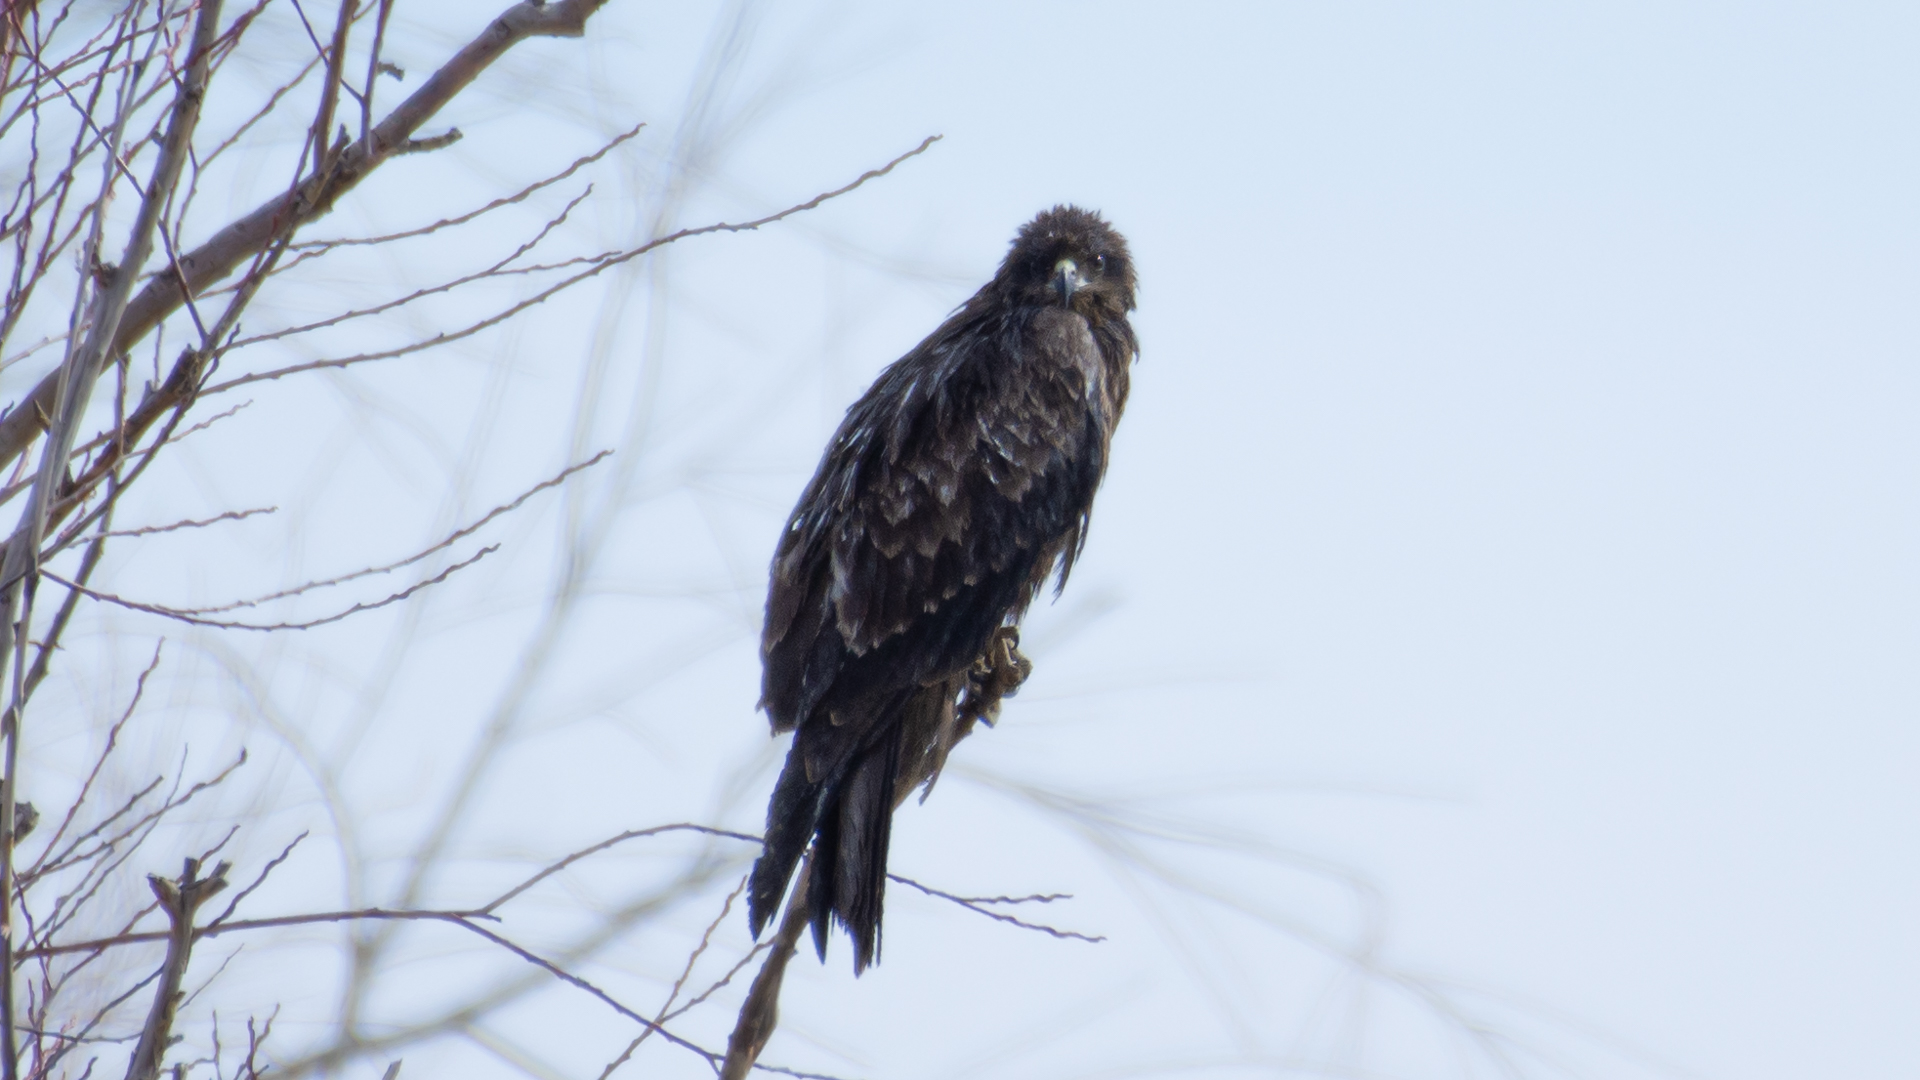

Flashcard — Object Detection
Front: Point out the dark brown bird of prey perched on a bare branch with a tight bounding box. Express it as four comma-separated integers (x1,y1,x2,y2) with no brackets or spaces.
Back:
747,206,1139,974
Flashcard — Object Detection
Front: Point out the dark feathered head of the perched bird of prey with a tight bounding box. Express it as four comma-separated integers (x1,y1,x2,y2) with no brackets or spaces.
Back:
996,206,1135,321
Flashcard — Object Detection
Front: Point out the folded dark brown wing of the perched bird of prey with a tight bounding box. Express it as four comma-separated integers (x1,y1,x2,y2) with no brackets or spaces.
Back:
762,311,1104,730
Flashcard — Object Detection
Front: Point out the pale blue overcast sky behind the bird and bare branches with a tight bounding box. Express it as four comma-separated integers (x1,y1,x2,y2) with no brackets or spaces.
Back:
8,0,1920,1080
